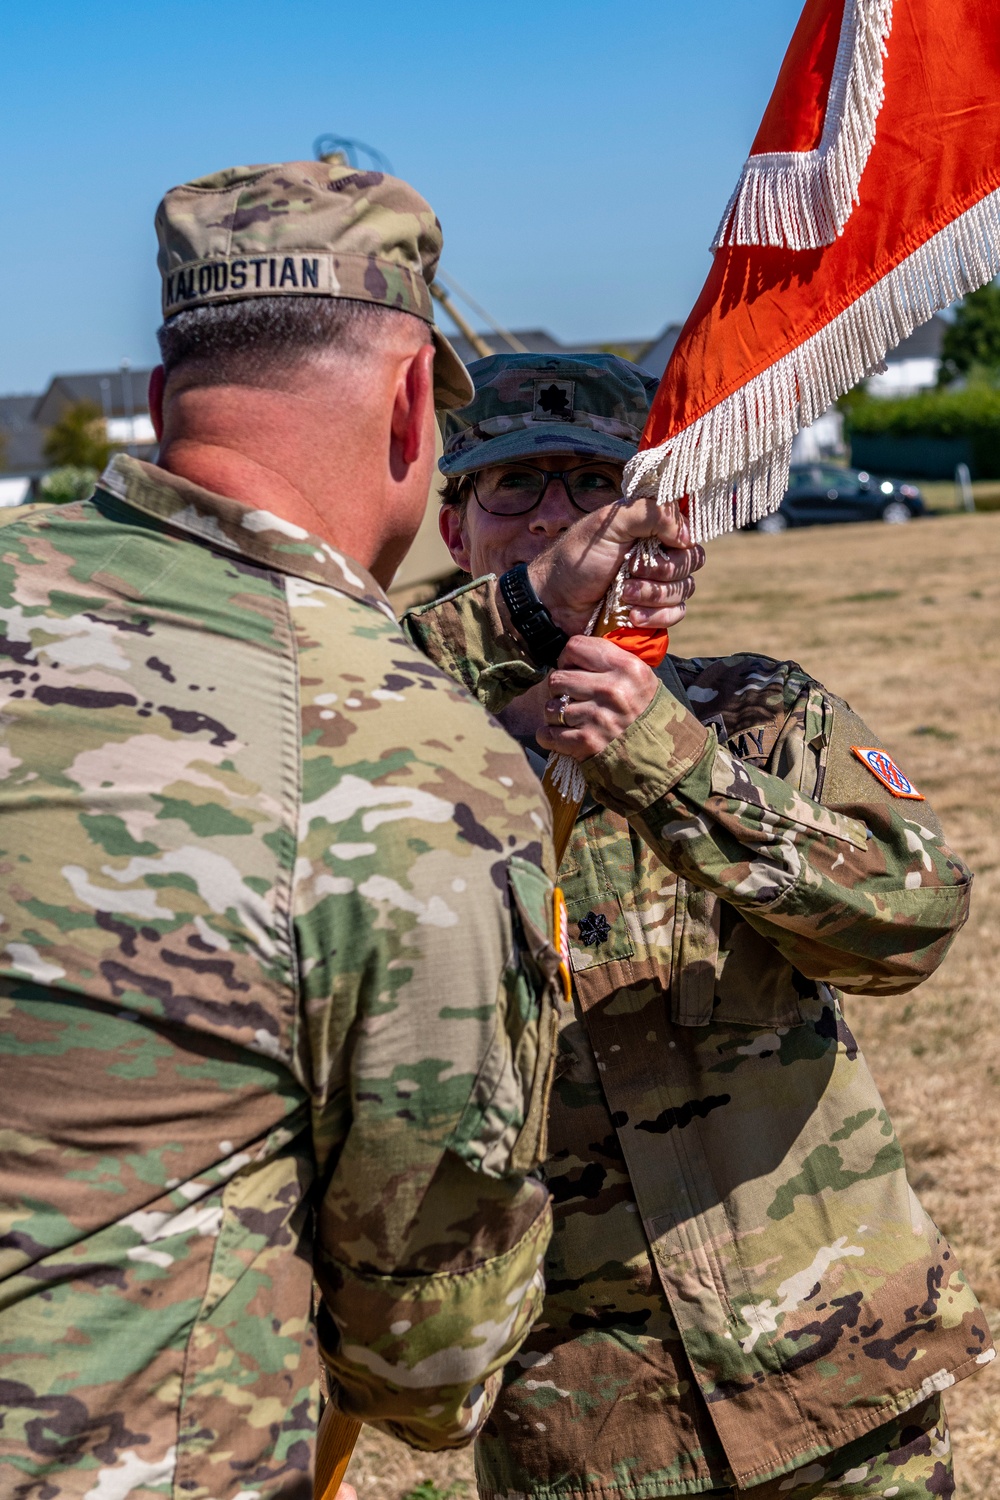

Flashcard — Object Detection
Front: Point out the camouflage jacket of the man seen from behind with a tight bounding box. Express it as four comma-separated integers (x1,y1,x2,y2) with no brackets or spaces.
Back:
0,459,564,1500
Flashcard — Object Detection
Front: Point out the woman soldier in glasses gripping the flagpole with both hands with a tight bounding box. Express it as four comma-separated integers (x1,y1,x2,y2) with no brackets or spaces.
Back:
408,356,994,1500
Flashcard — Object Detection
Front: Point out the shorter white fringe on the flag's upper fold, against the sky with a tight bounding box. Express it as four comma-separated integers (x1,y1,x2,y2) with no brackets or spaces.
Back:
712,0,892,251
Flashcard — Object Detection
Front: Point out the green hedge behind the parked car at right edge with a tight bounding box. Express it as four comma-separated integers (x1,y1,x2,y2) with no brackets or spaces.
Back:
844,386,1000,479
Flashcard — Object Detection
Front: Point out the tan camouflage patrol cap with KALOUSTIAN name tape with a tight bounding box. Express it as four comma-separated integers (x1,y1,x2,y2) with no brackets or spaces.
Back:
156,161,472,407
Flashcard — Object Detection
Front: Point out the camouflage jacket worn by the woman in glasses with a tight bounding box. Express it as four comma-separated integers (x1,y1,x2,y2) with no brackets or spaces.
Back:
406,579,993,1500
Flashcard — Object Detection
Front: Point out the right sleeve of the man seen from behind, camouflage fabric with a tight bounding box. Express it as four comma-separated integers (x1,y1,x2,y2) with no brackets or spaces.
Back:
294,609,561,1449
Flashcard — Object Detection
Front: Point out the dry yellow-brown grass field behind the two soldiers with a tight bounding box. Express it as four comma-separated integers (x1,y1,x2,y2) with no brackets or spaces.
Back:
348,515,1000,1500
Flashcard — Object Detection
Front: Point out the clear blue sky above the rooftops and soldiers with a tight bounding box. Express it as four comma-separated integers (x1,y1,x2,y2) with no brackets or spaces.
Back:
0,0,801,393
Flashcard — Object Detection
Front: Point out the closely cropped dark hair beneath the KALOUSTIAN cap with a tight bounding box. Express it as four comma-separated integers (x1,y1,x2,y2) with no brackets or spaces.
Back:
157,296,430,386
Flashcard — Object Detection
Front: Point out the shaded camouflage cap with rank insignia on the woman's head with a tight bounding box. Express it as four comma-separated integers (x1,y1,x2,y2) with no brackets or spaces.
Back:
438,354,657,474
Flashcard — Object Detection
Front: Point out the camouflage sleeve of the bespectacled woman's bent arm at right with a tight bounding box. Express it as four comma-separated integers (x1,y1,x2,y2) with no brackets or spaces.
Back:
583,687,972,992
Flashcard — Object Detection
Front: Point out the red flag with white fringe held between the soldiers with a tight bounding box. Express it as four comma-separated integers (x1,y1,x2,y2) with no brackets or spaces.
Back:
627,0,1000,540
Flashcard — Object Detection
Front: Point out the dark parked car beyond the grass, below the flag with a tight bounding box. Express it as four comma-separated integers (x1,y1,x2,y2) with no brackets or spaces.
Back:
754,464,927,531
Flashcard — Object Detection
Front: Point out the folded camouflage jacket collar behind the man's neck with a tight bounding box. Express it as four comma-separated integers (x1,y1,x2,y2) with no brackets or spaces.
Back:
100,453,396,620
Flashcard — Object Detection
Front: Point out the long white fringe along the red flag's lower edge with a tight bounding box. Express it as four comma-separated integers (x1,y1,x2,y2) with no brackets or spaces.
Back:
625,180,1000,542
